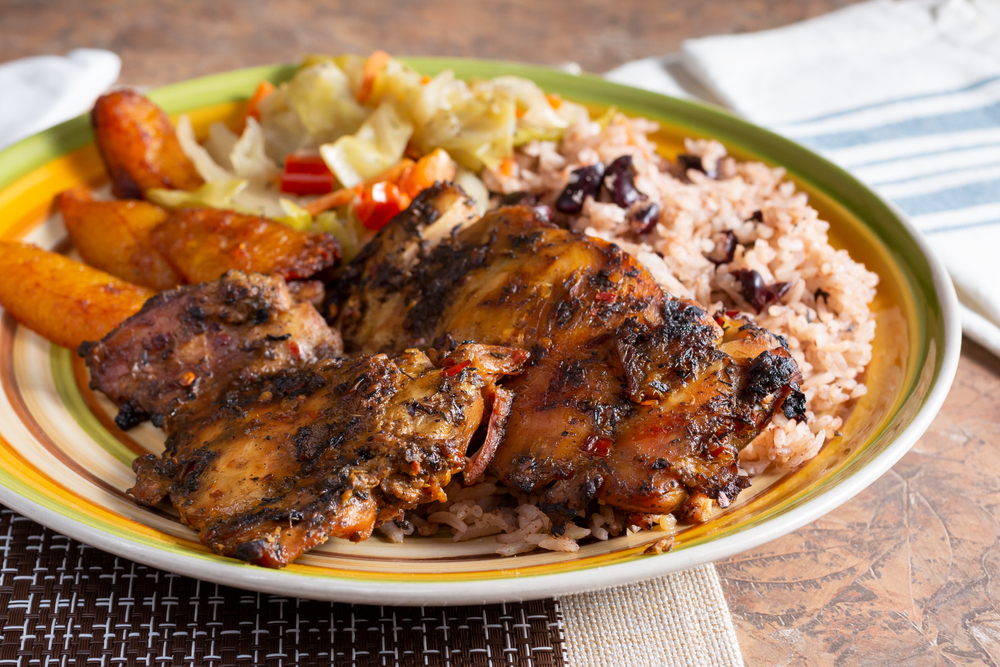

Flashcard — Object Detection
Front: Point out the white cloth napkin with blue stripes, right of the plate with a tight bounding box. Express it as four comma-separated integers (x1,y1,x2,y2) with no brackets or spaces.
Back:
606,0,1000,355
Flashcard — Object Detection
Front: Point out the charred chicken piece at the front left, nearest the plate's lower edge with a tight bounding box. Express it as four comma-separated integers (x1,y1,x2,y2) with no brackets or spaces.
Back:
129,345,528,567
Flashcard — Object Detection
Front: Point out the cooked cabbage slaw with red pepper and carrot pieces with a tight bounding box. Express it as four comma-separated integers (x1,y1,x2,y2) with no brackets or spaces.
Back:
160,51,588,260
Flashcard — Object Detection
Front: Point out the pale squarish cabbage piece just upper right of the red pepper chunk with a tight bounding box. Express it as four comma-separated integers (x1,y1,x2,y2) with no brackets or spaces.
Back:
319,101,413,188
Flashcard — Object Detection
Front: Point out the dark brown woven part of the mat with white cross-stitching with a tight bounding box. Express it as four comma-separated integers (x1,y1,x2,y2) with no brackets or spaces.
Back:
0,508,565,667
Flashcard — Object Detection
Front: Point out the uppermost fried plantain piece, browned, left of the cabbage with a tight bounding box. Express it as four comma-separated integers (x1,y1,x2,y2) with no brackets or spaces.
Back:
91,90,204,199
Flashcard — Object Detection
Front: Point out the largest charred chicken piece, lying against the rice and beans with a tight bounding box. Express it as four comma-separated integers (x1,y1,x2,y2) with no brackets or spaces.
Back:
335,185,804,526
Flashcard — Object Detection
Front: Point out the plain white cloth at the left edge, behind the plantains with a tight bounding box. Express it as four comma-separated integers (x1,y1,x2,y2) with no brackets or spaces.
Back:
0,49,122,149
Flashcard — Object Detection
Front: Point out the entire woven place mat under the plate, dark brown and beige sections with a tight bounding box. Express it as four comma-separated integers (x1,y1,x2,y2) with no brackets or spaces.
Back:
0,508,742,667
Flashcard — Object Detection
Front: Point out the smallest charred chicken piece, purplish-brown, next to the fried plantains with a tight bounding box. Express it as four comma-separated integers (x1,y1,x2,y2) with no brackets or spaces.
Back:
80,271,342,435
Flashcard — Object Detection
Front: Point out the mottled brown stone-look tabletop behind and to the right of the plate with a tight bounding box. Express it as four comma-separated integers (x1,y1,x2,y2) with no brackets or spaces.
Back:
0,0,1000,666
